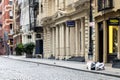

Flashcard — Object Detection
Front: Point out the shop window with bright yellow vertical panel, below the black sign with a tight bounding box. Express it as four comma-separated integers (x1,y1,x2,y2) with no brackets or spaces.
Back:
108,26,118,63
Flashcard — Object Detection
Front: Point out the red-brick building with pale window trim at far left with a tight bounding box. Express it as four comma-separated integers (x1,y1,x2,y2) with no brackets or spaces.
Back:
1,0,13,54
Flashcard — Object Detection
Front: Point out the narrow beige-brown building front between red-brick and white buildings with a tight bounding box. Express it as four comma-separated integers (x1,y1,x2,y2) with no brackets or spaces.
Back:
13,0,22,54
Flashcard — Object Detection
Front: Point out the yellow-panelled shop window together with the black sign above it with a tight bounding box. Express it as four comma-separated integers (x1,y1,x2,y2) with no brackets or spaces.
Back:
108,18,119,63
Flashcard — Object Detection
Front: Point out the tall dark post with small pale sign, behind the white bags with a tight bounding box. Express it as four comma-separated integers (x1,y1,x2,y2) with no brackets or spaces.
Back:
88,0,93,59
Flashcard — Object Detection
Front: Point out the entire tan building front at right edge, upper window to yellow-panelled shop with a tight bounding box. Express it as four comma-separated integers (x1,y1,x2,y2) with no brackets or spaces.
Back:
94,0,120,62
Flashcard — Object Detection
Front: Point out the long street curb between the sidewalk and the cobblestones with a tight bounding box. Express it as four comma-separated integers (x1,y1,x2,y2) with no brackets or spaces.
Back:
3,57,120,78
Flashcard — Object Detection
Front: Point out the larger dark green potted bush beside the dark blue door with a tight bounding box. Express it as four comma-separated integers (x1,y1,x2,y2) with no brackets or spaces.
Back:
24,42,35,58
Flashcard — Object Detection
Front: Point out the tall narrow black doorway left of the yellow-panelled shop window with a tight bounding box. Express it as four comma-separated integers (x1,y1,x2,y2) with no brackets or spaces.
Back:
98,22,103,62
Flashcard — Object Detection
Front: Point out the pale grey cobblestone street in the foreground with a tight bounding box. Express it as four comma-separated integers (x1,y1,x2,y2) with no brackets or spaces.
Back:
0,58,119,80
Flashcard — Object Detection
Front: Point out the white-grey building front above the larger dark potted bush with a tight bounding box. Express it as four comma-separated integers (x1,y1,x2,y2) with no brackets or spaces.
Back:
20,0,35,44
